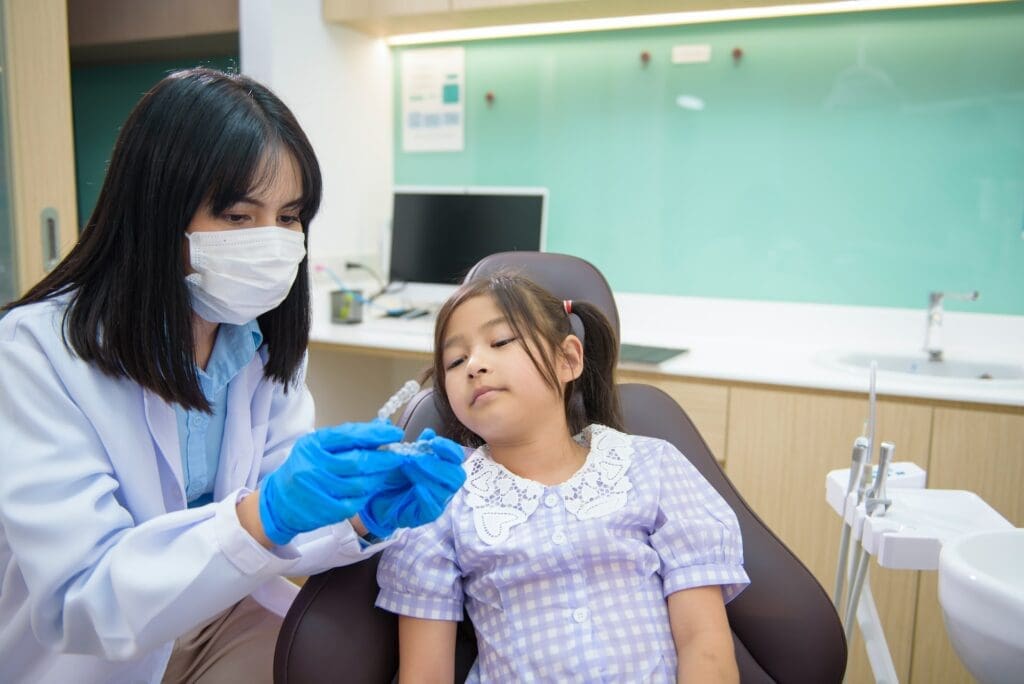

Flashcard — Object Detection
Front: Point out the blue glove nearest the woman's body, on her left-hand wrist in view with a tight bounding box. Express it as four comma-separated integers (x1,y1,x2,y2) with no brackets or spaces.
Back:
259,421,409,545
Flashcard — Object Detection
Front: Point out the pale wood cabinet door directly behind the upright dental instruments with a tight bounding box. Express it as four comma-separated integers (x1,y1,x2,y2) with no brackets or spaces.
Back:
725,386,941,682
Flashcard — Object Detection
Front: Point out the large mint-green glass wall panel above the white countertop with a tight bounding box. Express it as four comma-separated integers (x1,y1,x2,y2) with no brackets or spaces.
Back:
394,3,1024,314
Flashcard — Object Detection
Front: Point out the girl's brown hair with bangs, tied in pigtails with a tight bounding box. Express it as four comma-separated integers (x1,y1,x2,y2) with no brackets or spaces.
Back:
424,270,623,446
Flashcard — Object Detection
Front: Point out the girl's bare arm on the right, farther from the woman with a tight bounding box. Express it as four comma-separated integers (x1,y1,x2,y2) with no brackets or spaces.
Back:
669,585,739,683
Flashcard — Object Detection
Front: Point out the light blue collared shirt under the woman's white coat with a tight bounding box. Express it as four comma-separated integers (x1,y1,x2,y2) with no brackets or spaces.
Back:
174,320,263,508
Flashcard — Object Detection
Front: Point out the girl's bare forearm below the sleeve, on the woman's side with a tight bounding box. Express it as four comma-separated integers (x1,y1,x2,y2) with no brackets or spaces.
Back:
398,615,456,684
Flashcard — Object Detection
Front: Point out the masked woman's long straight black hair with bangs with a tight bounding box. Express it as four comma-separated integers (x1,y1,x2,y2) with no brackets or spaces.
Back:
6,68,322,412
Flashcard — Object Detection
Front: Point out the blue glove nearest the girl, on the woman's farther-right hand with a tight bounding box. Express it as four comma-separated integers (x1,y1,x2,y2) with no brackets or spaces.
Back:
359,429,466,538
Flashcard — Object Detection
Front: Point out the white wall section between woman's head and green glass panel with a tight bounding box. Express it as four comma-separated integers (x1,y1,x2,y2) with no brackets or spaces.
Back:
239,0,393,267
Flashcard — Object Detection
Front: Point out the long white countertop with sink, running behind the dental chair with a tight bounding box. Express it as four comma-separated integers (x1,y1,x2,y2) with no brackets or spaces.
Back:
310,292,1024,407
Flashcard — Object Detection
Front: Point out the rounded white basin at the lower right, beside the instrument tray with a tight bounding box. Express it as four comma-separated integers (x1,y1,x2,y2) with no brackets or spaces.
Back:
939,527,1024,684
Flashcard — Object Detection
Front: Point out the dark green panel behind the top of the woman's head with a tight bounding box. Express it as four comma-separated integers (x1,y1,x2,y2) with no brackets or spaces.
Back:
71,55,239,225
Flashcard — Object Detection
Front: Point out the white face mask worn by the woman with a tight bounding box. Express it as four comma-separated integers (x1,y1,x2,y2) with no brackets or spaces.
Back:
185,225,306,326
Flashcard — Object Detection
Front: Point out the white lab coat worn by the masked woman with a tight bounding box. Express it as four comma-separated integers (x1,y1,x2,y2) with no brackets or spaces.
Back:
0,297,380,683
